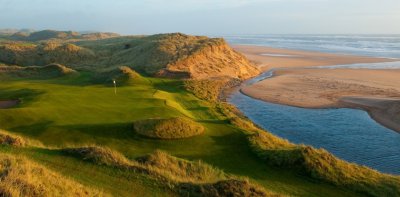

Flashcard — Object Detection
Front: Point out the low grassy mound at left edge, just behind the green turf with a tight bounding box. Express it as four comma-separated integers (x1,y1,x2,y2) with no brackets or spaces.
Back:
0,64,76,79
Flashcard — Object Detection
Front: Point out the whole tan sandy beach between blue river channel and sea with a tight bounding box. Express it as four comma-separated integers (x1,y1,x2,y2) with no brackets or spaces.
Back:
234,46,400,132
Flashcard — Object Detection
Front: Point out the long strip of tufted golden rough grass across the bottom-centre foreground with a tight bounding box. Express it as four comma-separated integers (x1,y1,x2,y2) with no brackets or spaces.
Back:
62,147,277,196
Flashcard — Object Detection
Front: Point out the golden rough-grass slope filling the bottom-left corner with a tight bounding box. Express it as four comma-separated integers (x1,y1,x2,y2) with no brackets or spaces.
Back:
0,154,104,196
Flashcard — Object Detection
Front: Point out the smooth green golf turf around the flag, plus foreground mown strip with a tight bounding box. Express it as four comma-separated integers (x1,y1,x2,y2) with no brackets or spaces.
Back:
0,73,357,196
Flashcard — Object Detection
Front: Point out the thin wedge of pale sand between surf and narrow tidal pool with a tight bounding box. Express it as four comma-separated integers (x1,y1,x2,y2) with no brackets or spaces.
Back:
232,45,394,70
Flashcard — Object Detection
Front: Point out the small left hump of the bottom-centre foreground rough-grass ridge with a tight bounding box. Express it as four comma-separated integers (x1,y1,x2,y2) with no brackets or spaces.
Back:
62,146,130,166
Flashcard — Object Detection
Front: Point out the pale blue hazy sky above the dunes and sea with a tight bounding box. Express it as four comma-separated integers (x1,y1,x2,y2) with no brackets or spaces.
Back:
0,0,400,35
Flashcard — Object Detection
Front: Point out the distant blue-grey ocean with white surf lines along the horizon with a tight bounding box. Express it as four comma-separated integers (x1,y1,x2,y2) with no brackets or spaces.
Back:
220,35,400,58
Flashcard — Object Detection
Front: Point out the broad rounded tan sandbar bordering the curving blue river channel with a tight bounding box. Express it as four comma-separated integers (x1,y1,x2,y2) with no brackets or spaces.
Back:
241,69,400,131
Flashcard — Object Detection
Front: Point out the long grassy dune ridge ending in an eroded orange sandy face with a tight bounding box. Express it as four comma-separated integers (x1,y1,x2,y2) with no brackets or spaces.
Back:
0,33,259,79
